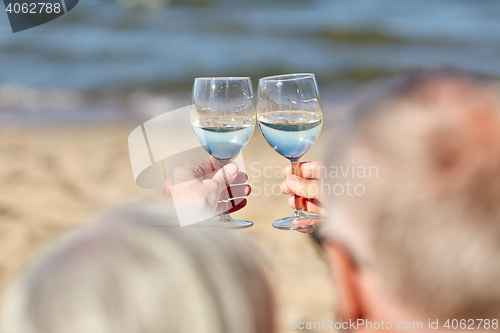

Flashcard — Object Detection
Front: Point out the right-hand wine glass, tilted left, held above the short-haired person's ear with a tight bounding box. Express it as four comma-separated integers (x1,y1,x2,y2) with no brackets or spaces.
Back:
257,74,323,230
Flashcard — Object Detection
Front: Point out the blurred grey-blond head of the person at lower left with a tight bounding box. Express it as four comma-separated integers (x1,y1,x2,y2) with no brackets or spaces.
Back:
2,201,273,333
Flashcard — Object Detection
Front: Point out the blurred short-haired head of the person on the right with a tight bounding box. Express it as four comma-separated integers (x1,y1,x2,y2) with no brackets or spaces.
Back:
329,70,500,318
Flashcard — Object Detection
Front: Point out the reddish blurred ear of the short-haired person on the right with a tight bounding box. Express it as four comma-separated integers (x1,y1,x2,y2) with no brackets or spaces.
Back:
324,242,365,321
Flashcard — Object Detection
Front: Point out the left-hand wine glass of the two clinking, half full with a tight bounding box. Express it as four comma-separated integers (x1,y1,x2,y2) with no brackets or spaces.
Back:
191,77,255,229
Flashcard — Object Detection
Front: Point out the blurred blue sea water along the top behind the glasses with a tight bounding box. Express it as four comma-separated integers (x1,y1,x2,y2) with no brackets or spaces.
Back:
0,0,500,118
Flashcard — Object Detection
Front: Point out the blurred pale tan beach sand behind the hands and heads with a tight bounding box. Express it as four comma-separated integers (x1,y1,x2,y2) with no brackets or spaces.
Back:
0,125,334,332
